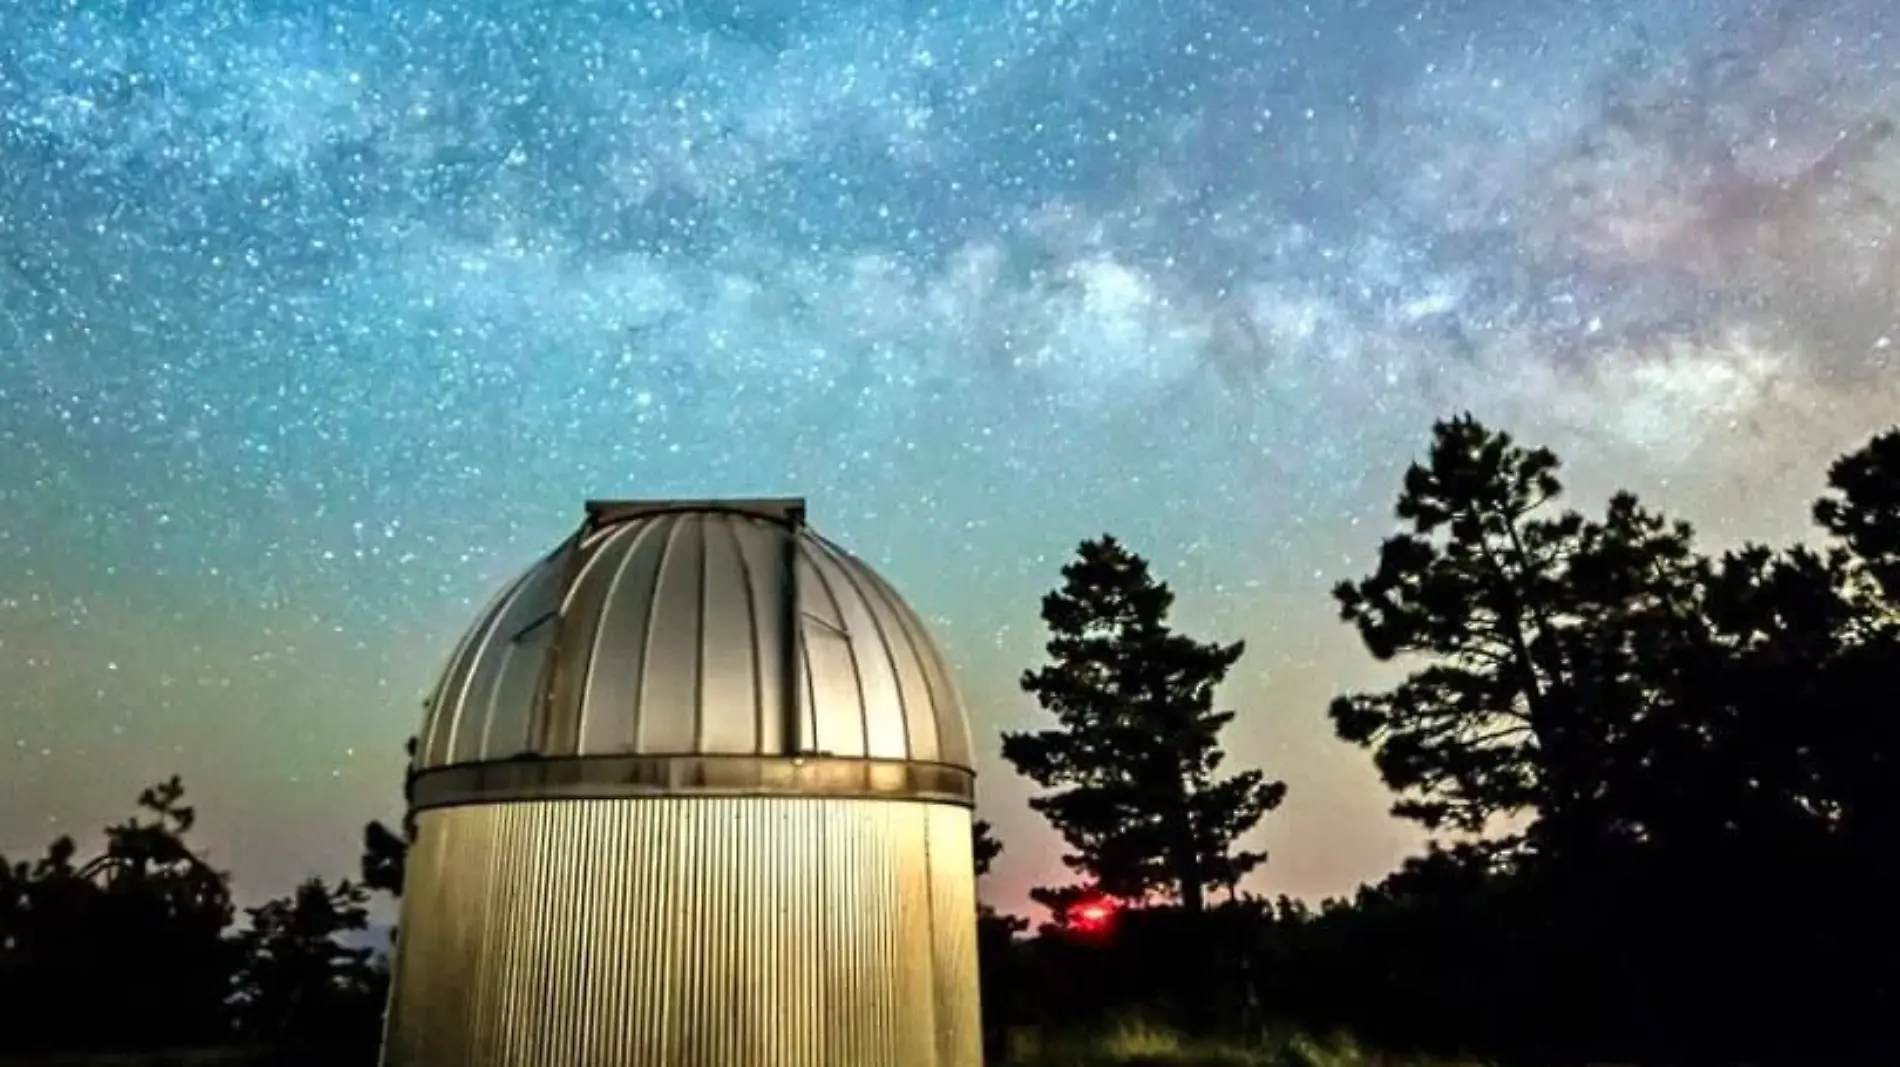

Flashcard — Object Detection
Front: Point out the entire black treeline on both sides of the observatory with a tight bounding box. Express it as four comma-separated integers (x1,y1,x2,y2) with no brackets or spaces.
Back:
0,418,1900,1067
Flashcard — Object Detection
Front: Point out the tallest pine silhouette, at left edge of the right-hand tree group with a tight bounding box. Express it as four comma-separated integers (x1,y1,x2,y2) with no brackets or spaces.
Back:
1332,416,1585,833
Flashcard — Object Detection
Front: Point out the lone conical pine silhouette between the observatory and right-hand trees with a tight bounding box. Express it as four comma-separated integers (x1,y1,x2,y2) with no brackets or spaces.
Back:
1003,535,1286,913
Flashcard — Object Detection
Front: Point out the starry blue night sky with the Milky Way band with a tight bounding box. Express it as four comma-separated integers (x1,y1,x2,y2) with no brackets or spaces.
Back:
0,0,1900,904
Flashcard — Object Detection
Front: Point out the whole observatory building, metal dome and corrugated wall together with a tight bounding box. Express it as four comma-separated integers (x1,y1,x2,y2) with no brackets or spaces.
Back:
382,499,982,1067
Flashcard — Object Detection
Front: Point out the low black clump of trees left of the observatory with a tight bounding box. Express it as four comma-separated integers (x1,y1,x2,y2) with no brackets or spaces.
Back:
0,778,388,1063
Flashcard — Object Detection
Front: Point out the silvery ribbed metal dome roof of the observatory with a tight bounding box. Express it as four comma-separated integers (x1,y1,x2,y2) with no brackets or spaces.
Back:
410,499,975,809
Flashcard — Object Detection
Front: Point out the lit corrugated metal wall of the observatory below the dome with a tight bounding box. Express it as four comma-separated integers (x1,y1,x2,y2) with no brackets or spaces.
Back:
384,797,982,1067
